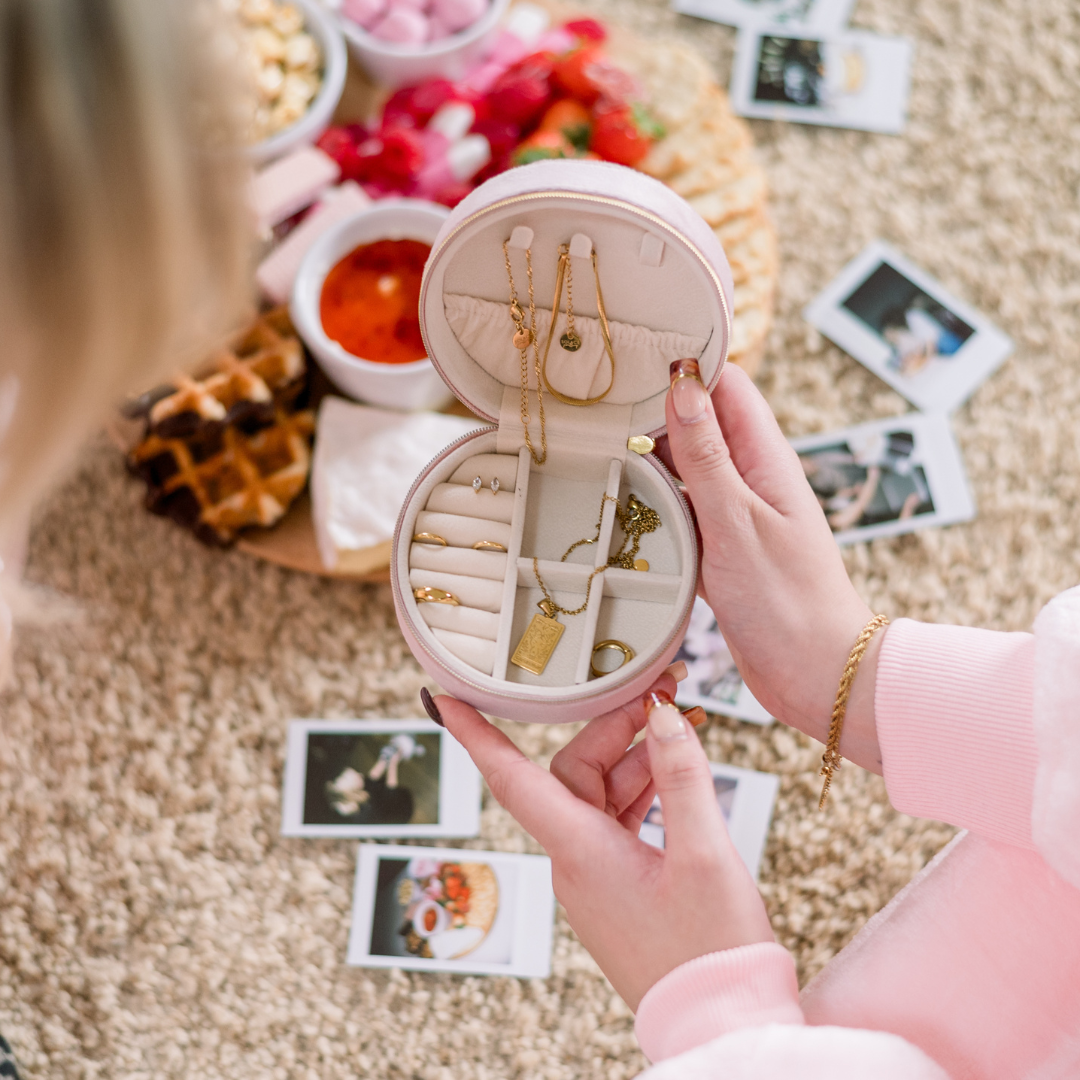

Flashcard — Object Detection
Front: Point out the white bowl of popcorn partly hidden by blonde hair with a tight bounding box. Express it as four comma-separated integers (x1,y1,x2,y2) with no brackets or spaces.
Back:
238,0,349,164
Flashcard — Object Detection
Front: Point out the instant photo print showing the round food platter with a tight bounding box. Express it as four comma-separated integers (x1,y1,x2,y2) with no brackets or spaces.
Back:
348,845,555,978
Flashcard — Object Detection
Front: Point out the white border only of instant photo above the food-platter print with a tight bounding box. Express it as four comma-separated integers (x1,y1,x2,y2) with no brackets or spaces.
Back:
281,719,483,839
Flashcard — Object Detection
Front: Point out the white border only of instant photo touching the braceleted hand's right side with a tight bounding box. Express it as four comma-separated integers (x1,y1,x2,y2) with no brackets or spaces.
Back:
791,413,975,544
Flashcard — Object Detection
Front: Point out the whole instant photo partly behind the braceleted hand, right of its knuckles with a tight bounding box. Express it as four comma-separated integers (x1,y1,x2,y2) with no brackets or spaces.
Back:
792,413,975,544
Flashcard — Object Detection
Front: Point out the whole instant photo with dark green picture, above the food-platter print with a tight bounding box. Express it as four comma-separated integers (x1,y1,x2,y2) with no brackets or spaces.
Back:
281,720,481,838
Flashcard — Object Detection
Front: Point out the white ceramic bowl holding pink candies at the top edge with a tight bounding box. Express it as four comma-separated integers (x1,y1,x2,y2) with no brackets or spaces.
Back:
338,0,510,90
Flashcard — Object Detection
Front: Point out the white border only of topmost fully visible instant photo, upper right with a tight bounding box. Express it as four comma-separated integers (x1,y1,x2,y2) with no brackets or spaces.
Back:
730,24,912,135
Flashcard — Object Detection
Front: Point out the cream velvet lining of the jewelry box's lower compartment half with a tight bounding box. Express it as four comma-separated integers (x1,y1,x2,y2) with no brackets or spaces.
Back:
403,433,688,689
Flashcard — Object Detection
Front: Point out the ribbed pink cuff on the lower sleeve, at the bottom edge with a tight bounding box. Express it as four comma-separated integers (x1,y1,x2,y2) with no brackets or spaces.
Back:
635,942,805,1062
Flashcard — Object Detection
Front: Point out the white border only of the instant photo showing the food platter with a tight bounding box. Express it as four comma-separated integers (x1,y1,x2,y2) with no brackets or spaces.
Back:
346,843,555,978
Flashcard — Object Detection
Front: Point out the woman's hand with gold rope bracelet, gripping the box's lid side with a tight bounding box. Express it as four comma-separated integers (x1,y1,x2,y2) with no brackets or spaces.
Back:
658,361,885,772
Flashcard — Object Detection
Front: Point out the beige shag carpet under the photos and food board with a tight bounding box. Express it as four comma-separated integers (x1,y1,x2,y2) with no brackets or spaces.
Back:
0,0,1080,1080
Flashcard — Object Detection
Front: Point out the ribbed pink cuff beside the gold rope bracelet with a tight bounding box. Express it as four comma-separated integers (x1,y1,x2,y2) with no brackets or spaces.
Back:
874,619,1038,848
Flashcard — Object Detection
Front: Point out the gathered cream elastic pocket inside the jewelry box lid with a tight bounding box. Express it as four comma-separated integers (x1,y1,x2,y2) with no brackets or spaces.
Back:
443,293,707,405
